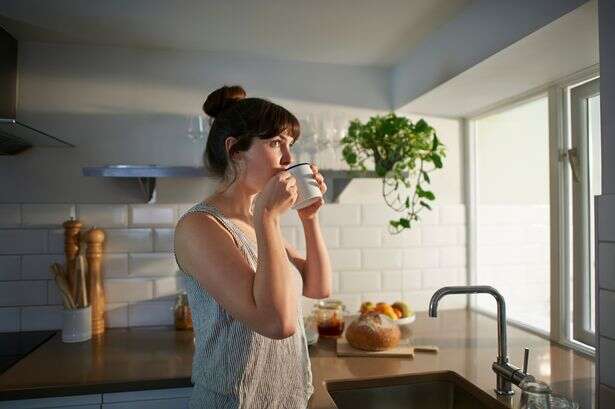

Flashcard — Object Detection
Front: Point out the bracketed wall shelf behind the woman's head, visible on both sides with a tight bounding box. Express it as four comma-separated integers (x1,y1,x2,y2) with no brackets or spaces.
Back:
82,165,378,203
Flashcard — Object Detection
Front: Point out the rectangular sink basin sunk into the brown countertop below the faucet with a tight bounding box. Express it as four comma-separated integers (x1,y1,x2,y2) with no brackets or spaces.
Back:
325,371,510,409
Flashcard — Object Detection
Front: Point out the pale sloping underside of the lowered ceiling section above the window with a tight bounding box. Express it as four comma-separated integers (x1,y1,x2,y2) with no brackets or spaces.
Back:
399,1,599,118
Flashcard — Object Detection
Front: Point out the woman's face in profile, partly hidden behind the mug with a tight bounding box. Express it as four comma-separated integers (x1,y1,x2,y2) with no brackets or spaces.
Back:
233,133,293,192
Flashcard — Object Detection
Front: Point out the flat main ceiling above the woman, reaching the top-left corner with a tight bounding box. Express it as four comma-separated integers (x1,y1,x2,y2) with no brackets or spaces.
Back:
0,0,470,67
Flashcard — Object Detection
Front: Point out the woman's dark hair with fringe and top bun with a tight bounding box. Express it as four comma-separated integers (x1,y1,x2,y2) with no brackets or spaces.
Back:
203,85,301,188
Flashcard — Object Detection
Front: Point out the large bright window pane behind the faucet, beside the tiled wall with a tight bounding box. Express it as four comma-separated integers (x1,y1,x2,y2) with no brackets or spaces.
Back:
474,97,550,332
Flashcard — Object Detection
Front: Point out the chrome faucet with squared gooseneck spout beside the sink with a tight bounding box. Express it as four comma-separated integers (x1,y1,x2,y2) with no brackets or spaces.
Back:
429,285,534,395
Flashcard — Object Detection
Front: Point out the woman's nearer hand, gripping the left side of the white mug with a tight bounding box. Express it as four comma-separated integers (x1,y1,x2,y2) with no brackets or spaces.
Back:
254,171,297,216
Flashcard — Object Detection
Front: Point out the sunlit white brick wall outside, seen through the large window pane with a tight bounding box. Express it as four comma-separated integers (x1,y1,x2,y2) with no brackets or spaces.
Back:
475,205,551,332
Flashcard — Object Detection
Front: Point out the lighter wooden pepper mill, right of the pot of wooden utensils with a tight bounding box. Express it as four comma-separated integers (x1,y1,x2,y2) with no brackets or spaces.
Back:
85,227,105,337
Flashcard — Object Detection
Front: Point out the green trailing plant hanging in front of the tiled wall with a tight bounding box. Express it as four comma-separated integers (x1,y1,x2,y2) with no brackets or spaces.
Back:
340,112,446,234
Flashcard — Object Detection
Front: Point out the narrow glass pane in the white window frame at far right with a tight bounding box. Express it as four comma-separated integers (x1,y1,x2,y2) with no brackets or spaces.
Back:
587,95,602,332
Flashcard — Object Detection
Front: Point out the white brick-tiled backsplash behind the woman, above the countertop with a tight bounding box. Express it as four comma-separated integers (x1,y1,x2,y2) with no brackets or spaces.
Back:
0,192,466,332
